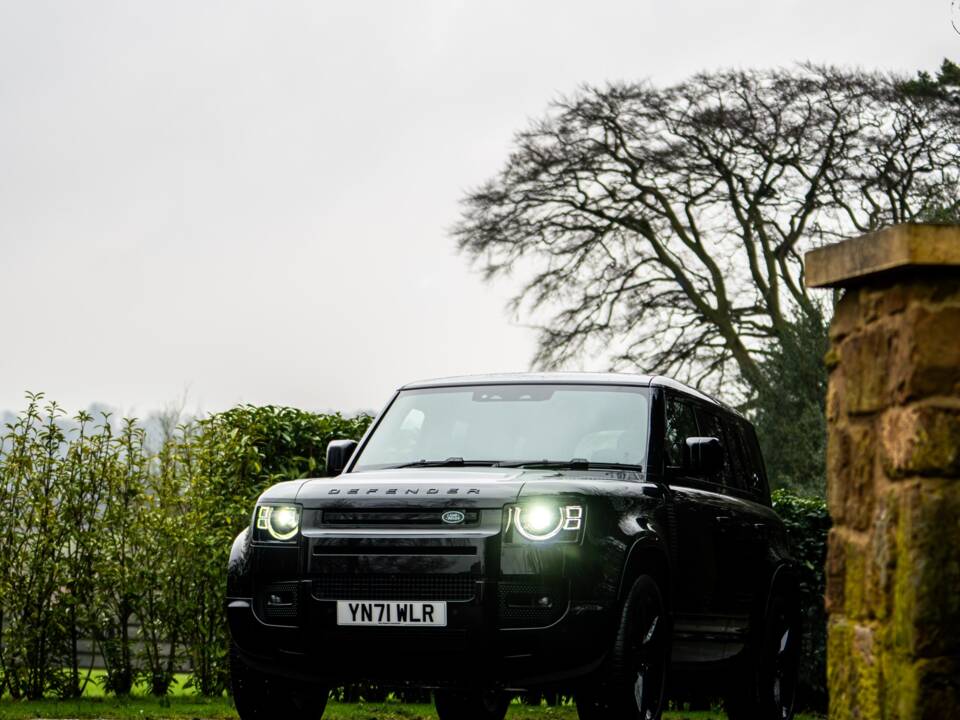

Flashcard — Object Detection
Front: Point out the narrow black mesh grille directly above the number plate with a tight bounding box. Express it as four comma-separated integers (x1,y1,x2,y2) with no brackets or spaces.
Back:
313,575,477,602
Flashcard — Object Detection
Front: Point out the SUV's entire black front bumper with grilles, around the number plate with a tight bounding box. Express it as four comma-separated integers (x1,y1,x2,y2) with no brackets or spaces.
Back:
227,521,615,689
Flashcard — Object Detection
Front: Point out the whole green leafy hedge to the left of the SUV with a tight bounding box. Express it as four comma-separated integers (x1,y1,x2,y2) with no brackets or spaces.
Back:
0,395,370,698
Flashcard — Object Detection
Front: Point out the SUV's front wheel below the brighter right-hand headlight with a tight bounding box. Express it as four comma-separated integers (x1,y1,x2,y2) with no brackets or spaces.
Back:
577,575,670,720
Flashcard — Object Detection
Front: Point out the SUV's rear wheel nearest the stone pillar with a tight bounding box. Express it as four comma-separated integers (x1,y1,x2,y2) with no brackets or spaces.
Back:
724,594,801,720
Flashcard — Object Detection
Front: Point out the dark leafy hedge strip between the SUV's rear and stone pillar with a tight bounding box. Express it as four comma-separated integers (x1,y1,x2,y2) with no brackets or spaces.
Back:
773,490,831,712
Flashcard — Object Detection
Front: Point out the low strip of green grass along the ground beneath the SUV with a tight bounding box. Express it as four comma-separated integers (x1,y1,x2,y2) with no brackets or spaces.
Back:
0,695,815,720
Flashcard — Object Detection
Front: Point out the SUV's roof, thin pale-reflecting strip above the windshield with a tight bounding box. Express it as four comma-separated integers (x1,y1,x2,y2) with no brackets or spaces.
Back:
400,372,736,412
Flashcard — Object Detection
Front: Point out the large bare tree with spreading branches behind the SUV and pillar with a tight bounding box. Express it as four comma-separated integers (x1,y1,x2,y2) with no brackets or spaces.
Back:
454,64,960,400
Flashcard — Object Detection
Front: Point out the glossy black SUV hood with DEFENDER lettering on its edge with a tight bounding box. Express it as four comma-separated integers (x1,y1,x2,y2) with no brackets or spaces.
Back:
296,468,643,508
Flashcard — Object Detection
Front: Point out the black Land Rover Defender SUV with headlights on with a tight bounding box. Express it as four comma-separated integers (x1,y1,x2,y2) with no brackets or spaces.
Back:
227,373,800,720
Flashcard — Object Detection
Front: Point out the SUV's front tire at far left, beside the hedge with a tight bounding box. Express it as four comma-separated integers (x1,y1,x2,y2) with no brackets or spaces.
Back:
230,646,330,720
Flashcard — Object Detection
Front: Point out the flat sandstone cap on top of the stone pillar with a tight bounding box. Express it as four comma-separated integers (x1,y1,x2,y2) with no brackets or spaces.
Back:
804,225,960,288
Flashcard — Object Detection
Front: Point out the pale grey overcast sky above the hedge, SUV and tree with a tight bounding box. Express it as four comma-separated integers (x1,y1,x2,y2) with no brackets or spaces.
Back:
0,0,960,413
